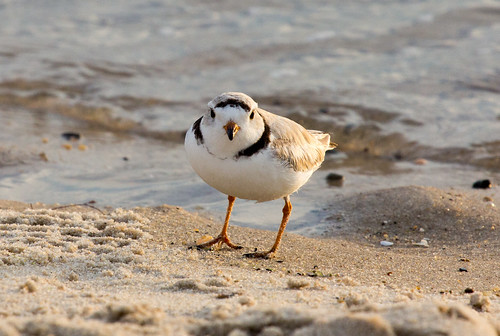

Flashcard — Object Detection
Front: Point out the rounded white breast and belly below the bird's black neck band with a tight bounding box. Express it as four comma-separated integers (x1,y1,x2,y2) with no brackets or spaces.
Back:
185,129,313,202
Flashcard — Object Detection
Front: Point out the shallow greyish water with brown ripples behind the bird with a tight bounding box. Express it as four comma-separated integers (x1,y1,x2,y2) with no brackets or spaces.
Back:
0,0,500,234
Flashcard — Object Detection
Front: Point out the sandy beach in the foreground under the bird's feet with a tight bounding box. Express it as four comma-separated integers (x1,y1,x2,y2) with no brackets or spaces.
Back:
0,187,500,336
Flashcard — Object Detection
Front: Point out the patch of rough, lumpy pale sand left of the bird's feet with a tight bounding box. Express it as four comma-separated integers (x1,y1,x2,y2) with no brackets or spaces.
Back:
0,209,149,265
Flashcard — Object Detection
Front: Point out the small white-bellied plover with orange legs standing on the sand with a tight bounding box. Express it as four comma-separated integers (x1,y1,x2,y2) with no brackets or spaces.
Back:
184,92,336,258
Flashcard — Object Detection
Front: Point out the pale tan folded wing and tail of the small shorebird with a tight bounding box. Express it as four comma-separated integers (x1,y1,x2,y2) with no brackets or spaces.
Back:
258,109,334,171
